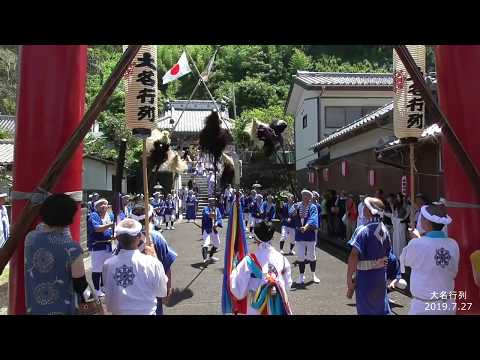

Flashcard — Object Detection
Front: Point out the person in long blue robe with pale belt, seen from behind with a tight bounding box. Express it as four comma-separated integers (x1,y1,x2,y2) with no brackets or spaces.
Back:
347,197,391,315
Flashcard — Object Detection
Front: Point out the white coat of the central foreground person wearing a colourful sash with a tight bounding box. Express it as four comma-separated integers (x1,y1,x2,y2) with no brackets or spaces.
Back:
230,243,292,315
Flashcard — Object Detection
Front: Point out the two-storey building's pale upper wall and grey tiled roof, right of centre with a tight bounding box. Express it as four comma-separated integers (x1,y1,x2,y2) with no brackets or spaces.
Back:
285,71,393,186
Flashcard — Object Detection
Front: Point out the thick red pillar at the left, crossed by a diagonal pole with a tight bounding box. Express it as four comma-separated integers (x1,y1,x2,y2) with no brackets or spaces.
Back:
9,45,87,314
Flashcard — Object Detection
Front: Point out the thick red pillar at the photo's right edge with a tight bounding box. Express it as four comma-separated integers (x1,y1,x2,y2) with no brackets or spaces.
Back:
436,46,480,314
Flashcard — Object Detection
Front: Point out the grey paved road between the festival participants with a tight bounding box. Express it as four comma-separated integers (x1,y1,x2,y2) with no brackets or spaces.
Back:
133,218,410,315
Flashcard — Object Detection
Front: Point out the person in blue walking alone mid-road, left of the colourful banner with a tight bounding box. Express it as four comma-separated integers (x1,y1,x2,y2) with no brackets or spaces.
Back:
202,198,223,263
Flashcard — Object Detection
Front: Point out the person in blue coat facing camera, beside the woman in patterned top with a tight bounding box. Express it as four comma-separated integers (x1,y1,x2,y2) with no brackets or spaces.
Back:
87,199,114,297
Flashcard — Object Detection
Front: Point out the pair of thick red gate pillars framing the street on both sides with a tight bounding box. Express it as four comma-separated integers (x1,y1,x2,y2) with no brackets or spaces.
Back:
0,45,480,314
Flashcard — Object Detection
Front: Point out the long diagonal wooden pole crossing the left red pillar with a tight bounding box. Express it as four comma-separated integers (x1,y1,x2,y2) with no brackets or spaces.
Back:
0,45,141,274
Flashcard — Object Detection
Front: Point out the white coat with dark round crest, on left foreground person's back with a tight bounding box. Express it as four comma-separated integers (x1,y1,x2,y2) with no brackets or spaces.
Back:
103,249,168,315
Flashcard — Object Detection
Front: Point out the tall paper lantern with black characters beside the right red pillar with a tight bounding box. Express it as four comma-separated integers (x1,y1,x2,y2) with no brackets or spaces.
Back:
393,45,426,139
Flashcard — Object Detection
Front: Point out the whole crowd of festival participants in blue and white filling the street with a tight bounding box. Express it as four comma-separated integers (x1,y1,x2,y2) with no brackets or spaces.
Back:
19,153,459,315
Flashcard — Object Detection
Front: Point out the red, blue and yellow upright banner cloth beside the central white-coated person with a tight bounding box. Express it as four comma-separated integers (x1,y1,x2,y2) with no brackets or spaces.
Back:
222,195,248,314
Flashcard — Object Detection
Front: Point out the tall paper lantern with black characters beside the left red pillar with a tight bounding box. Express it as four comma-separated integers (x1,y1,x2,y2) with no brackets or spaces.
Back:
123,45,158,136
